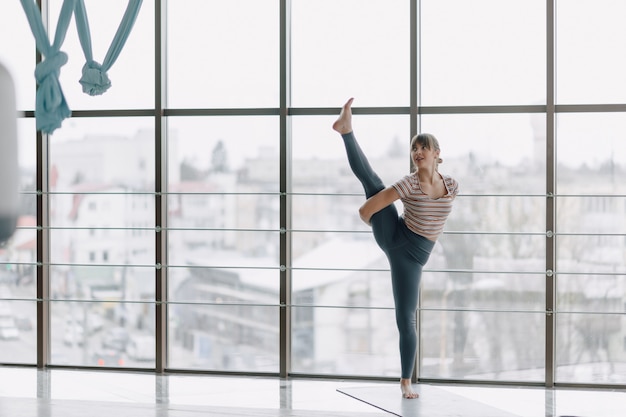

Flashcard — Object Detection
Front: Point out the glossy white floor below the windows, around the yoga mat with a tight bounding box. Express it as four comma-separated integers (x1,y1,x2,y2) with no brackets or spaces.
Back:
0,367,626,417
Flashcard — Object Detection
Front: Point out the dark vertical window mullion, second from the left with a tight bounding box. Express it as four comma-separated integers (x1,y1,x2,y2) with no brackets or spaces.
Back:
154,0,168,373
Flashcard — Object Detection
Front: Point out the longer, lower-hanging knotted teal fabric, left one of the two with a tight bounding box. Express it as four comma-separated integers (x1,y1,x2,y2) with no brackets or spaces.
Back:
20,0,75,133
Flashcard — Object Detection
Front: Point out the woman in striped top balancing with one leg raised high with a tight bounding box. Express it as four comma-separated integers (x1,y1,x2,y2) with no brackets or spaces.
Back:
333,98,458,398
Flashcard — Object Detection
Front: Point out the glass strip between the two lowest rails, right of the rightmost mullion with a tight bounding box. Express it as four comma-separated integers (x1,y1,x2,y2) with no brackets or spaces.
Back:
557,273,626,313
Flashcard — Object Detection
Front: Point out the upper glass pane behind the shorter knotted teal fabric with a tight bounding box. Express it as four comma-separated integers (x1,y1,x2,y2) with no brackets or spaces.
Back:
50,0,155,109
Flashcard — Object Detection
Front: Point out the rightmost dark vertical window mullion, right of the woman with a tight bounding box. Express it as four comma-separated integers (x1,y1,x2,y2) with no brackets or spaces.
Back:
545,0,557,388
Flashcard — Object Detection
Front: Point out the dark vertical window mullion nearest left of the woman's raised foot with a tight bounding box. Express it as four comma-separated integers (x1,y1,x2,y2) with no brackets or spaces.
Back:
279,0,292,378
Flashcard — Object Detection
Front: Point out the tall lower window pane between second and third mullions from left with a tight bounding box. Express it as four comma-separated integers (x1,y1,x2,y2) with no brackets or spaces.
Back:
168,116,280,372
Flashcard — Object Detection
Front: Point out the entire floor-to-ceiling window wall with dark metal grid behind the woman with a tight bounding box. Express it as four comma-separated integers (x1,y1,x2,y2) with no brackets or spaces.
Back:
0,0,626,386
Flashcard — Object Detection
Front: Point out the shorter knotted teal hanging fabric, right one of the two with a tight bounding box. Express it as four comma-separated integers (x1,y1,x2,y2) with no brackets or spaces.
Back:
75,0,142,96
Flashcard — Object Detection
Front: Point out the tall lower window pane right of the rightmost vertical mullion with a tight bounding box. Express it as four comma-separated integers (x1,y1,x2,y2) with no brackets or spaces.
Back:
556,113,626,382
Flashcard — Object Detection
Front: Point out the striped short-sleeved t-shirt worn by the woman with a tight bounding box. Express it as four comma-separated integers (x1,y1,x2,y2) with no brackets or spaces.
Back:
393,171,459,240
